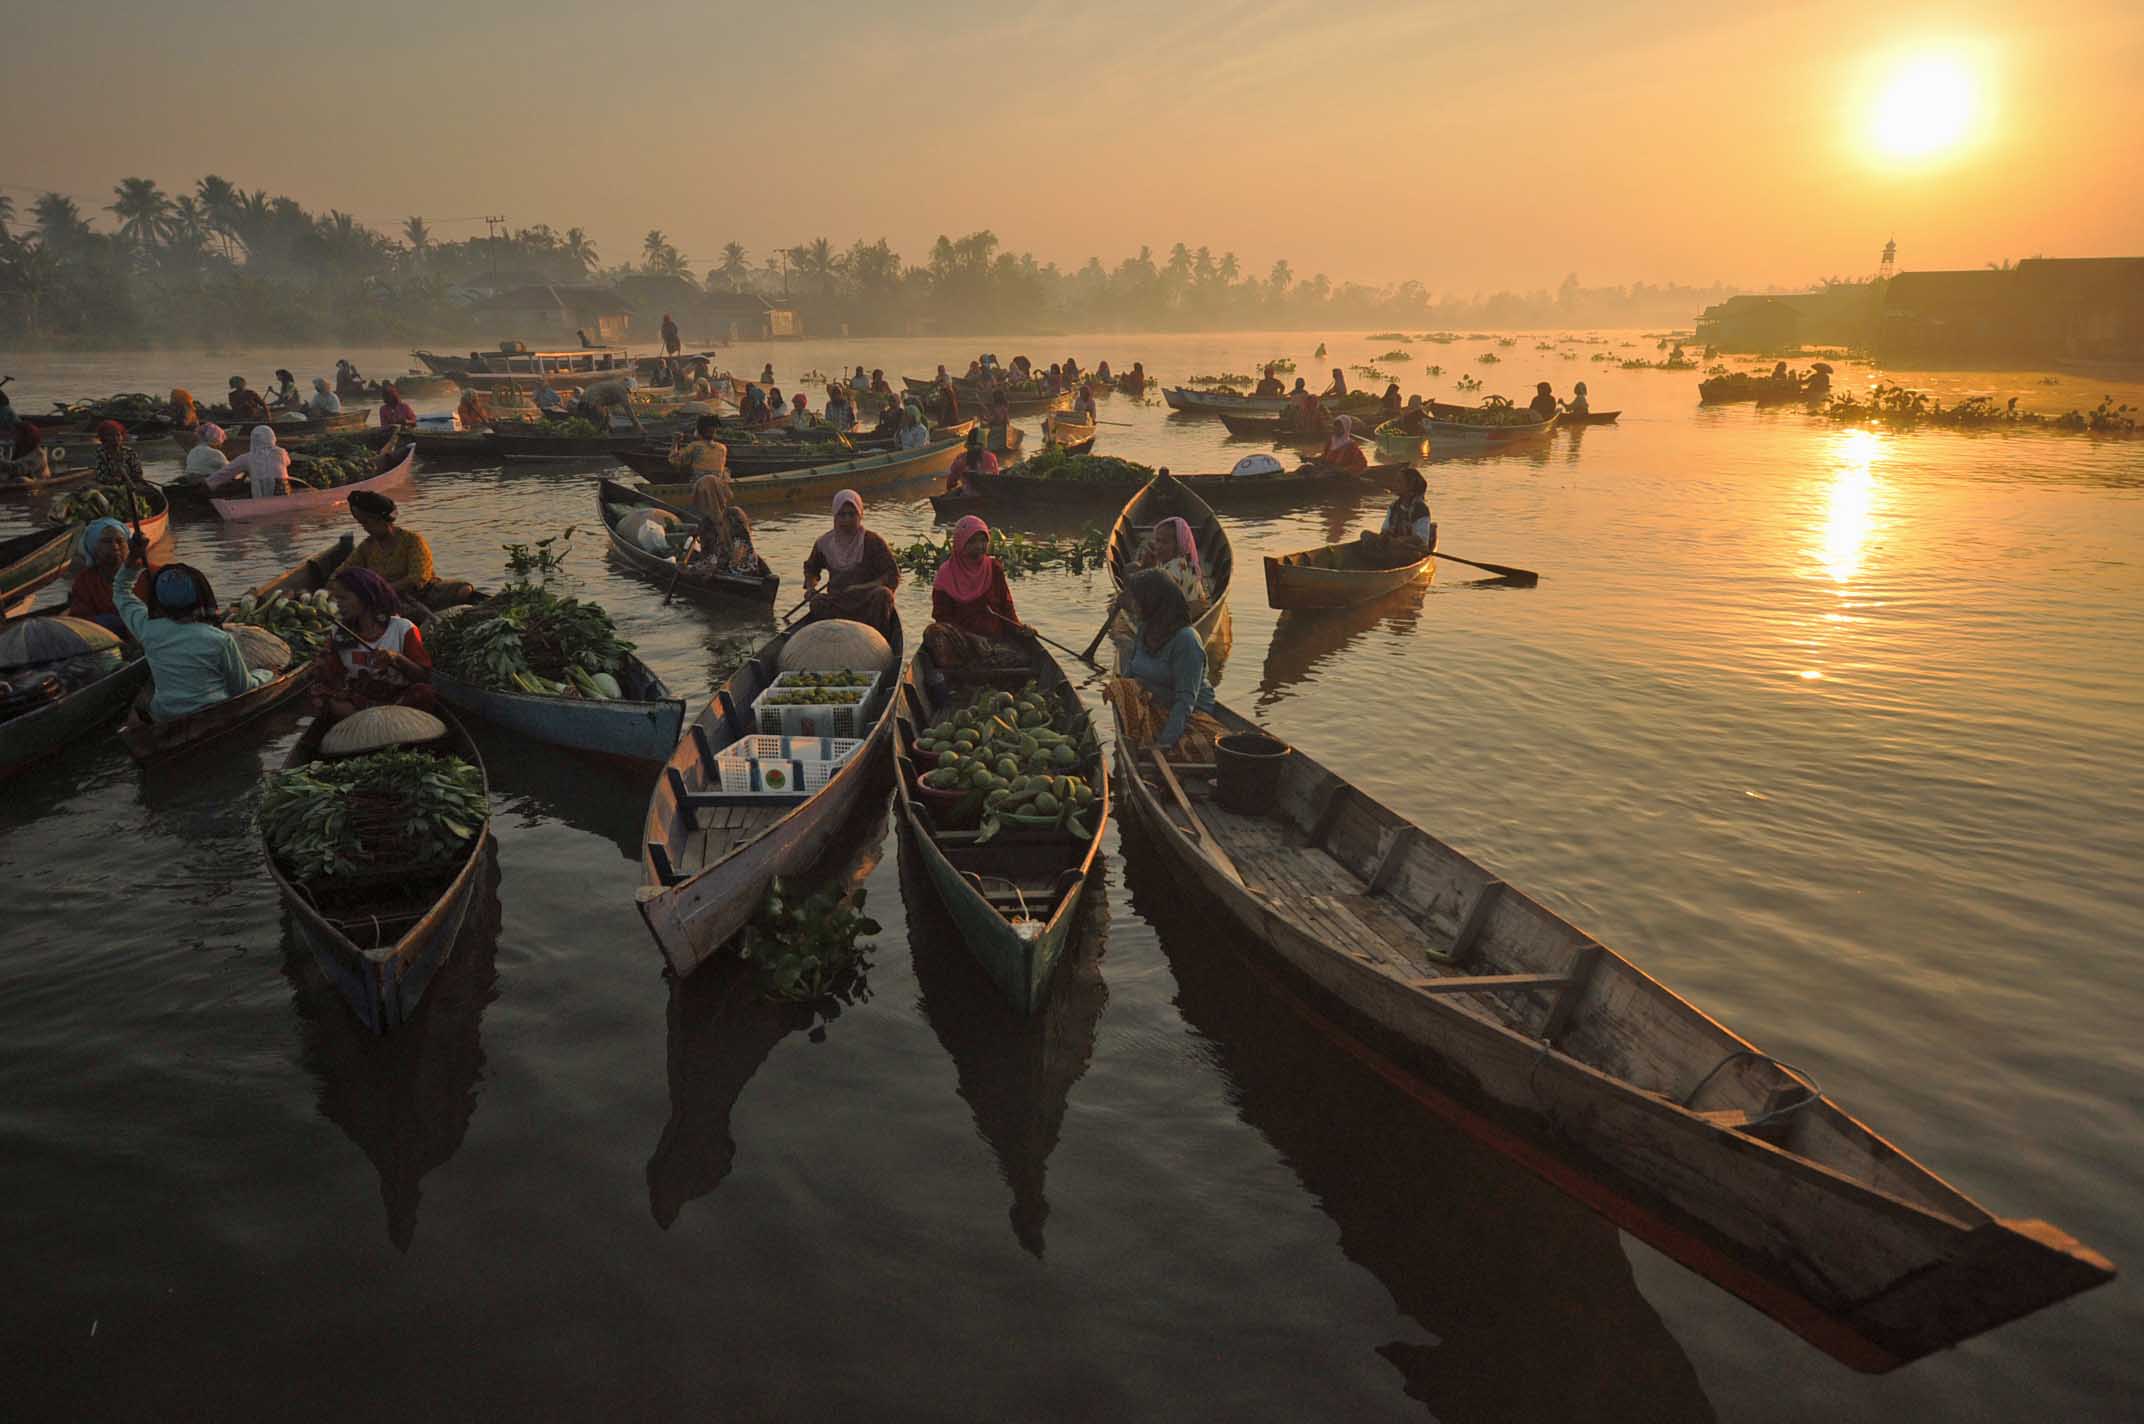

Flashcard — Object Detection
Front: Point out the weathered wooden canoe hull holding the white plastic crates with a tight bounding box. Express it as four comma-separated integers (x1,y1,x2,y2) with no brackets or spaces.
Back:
637,620,903,976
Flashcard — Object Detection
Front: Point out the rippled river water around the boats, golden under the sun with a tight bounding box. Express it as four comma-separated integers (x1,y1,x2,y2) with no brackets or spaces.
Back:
0,332,2144,1422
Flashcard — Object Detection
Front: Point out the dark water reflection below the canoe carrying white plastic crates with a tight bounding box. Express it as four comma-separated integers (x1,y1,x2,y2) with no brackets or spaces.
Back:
647,789,892,1231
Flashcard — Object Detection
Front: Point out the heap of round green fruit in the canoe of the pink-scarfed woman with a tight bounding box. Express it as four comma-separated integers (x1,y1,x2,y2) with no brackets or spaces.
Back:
915,680,1100,845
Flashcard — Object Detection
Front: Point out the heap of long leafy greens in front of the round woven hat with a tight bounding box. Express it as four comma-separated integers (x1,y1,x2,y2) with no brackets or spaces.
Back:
259,751,489,881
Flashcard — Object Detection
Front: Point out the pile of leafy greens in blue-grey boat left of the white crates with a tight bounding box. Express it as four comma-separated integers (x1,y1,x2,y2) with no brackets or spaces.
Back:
425,583,632,701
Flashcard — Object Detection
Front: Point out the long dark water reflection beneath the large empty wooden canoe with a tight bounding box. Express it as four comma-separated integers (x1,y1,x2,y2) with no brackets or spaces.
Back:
1121,817,1717,1422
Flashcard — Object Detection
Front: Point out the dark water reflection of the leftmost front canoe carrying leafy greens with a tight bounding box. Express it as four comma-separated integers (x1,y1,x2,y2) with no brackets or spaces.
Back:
283,856,500,1250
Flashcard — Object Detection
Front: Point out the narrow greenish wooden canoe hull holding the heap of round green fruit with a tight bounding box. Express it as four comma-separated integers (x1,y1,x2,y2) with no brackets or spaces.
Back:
894,641,1108,1014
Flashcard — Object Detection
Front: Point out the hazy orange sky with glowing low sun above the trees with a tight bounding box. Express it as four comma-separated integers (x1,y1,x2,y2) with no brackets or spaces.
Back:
0,0,2144,292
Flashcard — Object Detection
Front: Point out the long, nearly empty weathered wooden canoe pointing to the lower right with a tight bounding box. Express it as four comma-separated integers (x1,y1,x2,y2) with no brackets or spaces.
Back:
1115,708,2114,1370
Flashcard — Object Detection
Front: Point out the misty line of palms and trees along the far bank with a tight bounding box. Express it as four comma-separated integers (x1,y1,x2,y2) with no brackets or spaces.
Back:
0,174,1734,347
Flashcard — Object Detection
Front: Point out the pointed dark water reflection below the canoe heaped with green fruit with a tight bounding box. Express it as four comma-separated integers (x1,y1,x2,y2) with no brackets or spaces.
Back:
898,836,1108,1257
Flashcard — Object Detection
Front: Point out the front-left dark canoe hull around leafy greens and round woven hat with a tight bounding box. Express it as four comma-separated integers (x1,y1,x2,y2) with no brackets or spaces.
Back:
262,708,491,1034
